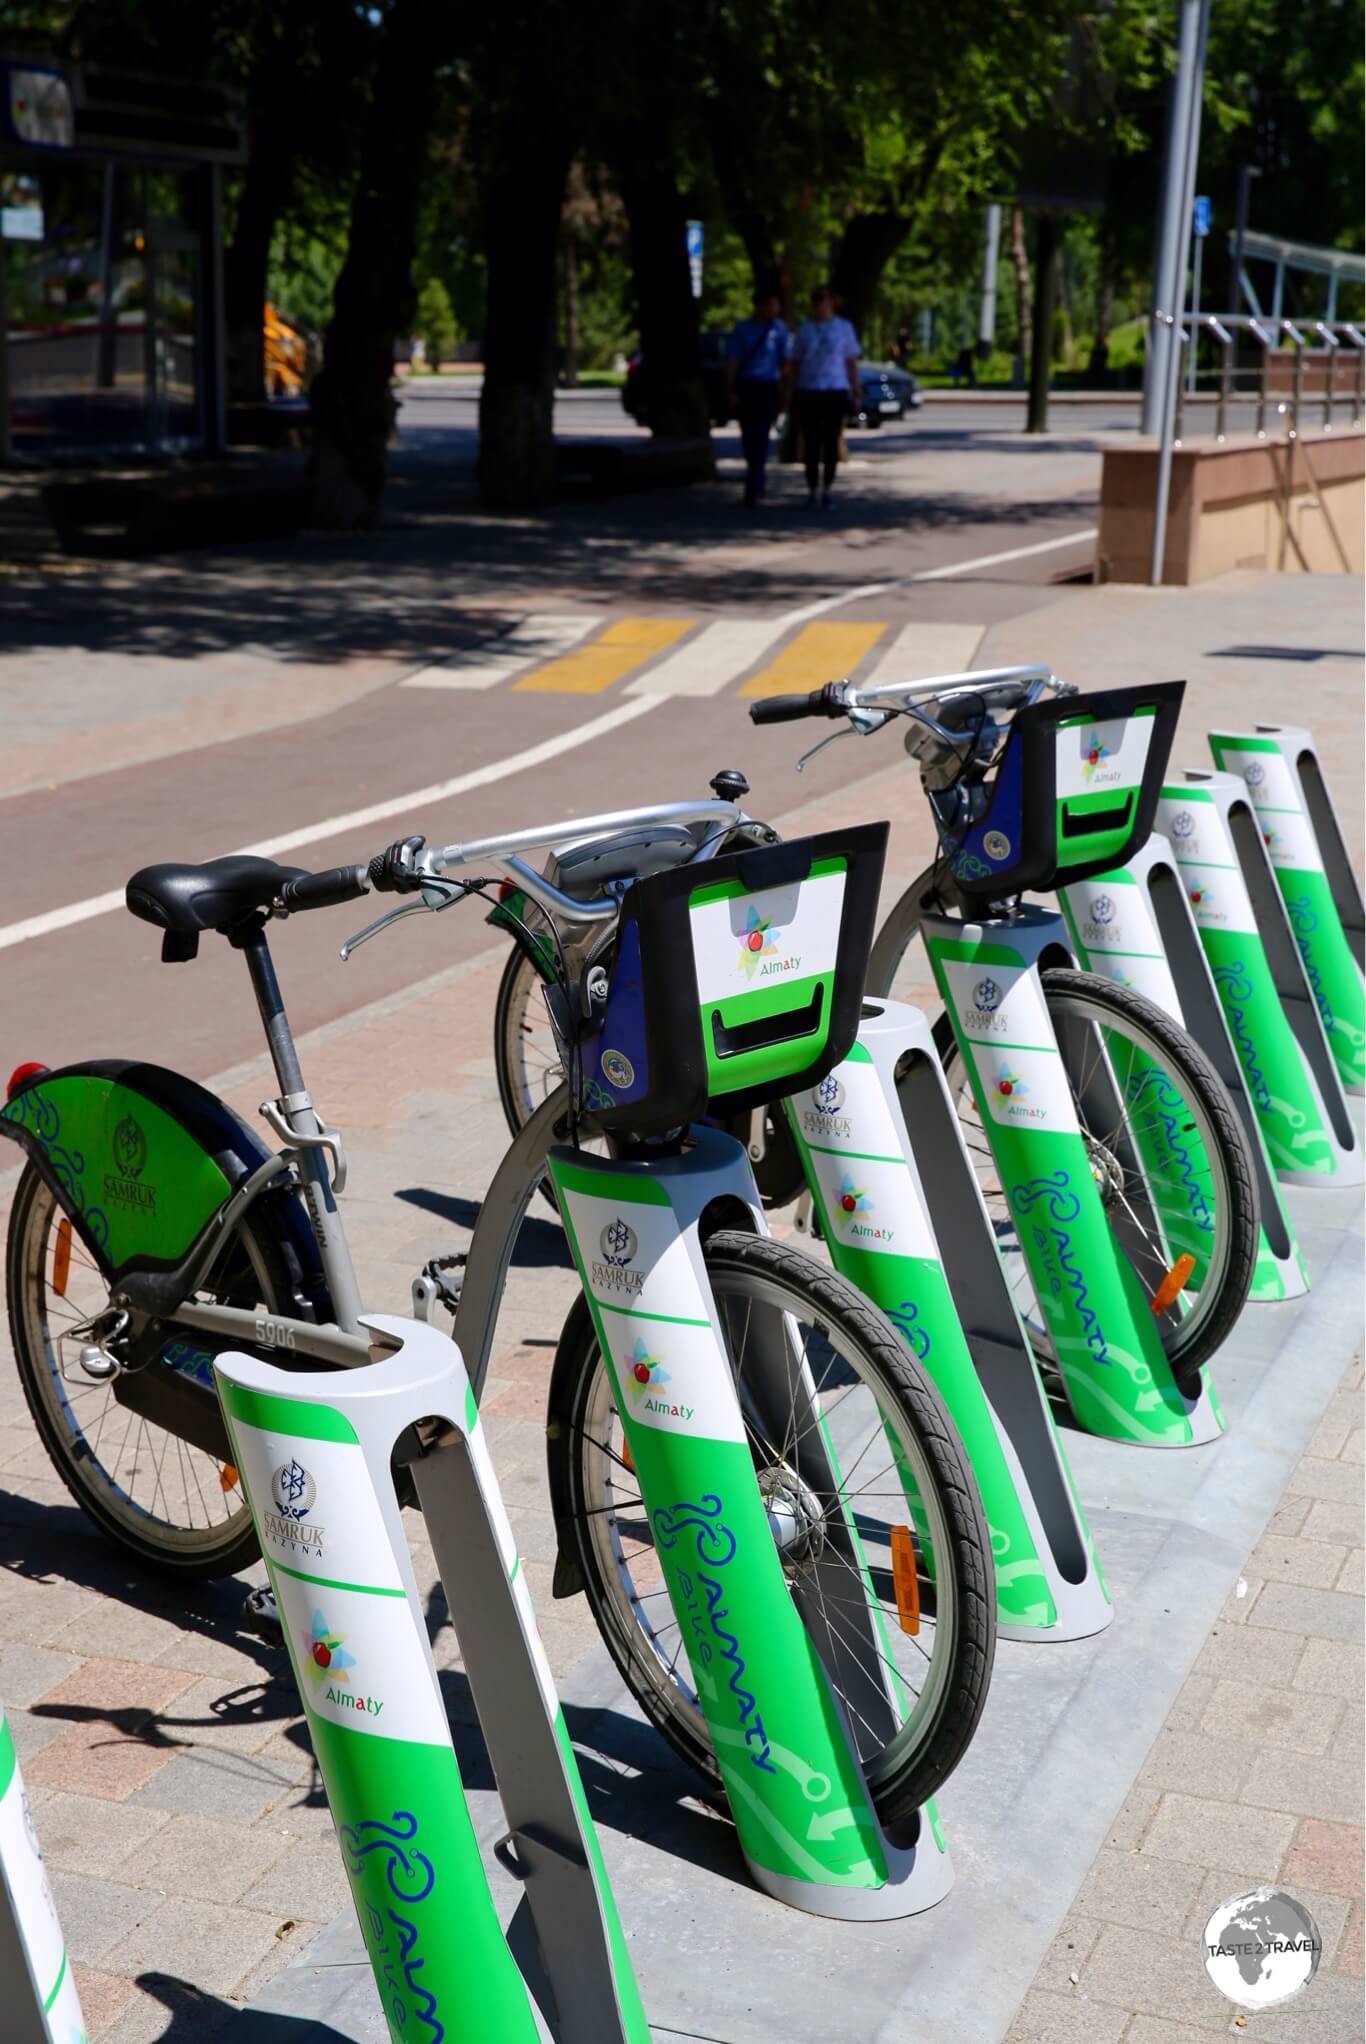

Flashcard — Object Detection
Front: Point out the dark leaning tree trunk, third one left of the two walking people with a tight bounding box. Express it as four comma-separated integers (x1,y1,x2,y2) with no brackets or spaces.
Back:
309,0,452,529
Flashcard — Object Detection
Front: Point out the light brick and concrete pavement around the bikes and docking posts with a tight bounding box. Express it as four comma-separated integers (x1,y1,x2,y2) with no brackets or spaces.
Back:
0,578,1362,2044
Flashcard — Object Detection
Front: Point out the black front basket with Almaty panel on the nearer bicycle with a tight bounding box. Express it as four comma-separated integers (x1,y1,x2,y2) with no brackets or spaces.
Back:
581,824,887,1134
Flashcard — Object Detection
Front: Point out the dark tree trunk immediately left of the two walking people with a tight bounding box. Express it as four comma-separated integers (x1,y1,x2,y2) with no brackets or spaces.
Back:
618,156,712,439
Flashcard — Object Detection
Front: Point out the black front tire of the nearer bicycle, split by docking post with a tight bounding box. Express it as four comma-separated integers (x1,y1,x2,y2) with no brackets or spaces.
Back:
556,1230,996,1825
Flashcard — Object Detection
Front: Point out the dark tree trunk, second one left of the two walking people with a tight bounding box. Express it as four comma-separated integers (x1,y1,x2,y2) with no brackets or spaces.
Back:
476,135,573,511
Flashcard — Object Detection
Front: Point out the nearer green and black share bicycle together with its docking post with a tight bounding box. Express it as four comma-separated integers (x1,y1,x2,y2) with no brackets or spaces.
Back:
0,799,994,1915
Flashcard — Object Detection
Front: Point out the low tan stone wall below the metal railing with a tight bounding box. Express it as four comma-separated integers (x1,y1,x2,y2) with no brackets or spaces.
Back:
1096,427,1366,583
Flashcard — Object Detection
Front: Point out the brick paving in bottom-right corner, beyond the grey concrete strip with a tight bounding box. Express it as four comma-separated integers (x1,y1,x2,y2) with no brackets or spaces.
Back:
1006,1361,1366,2044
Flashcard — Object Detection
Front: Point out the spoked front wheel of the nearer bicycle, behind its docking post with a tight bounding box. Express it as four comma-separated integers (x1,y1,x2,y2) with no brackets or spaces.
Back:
556,1233,996,1823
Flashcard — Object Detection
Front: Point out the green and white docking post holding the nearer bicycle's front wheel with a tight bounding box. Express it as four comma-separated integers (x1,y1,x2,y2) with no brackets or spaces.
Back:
548,1128,953,1919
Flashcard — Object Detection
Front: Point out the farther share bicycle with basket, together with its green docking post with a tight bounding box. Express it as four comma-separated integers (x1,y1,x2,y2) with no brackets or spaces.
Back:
764,666,1258,1447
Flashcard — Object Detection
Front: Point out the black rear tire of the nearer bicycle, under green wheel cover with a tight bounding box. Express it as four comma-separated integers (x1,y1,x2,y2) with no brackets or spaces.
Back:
4,1163,292,1582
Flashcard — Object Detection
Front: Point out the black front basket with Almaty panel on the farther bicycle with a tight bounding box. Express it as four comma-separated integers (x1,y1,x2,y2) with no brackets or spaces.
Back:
941,681,1186,901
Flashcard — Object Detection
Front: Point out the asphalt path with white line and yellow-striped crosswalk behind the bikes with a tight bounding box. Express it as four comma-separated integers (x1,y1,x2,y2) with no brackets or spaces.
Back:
0,392,1098,1077
